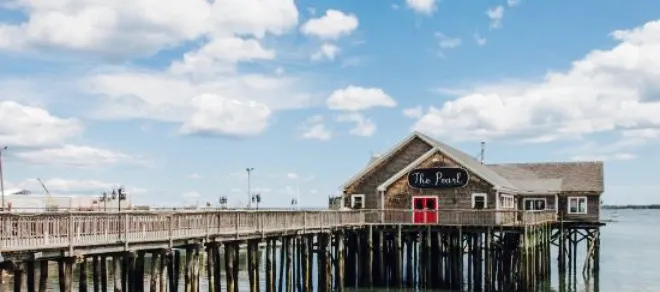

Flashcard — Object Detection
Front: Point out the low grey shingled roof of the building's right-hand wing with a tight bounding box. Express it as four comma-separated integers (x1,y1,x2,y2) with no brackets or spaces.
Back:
487,161,604,193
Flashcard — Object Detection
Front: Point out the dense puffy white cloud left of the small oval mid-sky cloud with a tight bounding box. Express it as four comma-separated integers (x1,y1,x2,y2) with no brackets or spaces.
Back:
180,94,271,137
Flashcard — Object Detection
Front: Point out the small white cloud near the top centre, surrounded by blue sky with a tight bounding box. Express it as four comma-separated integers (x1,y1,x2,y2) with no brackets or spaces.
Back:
300,9,359,39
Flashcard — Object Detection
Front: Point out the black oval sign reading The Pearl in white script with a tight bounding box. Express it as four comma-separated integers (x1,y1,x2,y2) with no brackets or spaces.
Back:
408,167,470,189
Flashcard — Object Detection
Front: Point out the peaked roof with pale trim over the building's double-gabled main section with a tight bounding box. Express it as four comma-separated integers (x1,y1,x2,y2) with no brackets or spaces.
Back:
344,131,518,191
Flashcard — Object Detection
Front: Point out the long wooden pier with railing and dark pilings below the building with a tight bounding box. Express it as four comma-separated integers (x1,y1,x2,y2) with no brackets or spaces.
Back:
0,209,600,292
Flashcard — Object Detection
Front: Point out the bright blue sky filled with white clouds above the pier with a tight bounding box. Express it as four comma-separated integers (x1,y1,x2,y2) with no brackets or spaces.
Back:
0,0,660,207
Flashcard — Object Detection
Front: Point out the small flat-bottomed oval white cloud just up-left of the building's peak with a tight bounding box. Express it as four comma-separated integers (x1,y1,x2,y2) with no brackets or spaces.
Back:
326,85,396,111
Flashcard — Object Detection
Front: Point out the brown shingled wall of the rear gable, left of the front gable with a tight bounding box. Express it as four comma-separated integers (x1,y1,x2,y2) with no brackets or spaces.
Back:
344,138,433,209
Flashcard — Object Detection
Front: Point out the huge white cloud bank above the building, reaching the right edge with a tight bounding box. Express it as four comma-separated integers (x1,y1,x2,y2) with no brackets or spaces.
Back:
414,21,660,142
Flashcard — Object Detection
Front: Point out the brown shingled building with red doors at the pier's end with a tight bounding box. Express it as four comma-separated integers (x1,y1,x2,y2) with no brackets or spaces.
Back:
341,132,603,223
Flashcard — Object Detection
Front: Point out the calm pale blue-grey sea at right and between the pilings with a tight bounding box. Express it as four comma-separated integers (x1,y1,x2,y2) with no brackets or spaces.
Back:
0,210,660,292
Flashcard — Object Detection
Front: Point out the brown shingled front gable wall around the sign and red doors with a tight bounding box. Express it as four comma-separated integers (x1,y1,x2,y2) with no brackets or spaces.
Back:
385,153,495,209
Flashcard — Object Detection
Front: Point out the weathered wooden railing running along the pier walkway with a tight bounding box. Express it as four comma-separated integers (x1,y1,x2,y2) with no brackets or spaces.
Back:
0,210,556,252
